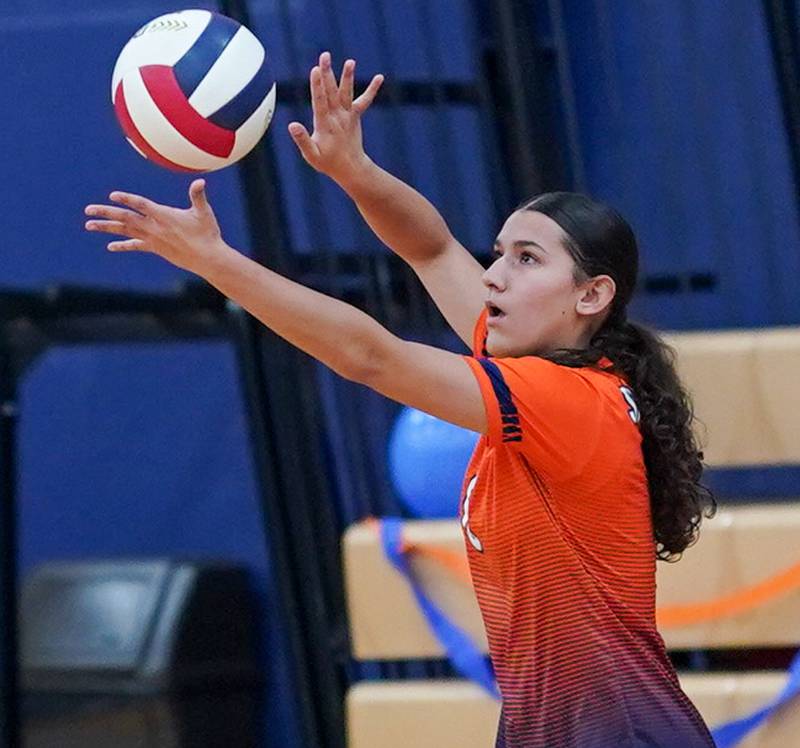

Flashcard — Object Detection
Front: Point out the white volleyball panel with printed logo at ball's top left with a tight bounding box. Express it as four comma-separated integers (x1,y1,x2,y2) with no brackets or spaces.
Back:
111,10,212,101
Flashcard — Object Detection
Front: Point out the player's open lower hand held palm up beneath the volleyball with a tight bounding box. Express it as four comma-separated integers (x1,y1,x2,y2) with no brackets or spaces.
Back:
85,179,234,275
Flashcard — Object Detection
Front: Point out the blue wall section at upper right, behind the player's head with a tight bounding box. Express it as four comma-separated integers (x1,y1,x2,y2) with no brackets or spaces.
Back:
564,0,800,329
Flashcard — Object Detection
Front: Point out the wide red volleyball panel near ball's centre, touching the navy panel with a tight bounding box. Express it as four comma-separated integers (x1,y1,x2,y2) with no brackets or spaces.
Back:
139,65,236,158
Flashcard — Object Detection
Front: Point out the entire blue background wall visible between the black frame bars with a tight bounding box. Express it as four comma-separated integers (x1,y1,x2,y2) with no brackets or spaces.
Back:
0,0,800,745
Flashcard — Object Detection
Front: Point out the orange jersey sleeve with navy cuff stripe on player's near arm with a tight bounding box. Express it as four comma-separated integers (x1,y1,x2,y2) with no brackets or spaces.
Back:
464,314,606,483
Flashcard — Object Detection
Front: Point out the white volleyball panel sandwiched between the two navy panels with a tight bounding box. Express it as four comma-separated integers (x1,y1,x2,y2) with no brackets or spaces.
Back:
189,26,265,117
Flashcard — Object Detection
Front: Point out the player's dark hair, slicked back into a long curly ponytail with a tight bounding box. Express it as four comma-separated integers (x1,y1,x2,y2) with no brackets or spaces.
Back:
518,192,717,561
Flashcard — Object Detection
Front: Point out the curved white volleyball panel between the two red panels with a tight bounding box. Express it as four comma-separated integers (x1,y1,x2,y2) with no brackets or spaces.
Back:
122,70,232,171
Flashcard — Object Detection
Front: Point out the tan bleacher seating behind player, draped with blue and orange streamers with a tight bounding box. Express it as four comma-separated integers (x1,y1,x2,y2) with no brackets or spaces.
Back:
343,328,800,748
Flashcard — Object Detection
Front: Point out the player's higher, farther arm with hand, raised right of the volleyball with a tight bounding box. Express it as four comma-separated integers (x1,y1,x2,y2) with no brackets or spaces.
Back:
289,52,485,345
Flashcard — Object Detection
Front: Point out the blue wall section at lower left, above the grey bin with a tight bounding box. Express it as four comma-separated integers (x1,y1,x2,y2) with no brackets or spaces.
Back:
19,343,296,746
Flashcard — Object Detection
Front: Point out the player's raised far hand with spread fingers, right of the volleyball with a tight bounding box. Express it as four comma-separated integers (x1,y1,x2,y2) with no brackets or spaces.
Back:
289,52,383,185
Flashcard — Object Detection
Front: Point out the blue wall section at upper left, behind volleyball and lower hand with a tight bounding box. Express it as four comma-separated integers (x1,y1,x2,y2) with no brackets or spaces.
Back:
0,1,246,289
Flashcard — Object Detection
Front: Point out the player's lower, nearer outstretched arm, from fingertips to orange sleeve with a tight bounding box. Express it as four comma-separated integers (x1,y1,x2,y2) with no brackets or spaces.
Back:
86,179,487,432
